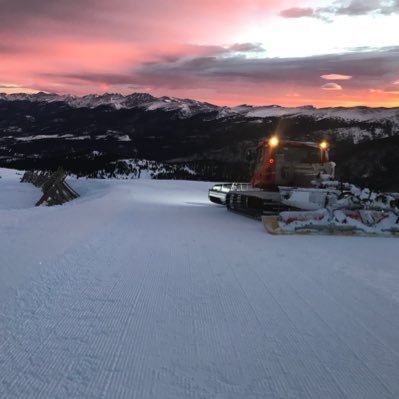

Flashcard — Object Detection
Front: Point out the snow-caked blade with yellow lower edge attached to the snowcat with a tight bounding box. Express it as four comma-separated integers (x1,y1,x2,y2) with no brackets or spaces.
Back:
262,209,399,237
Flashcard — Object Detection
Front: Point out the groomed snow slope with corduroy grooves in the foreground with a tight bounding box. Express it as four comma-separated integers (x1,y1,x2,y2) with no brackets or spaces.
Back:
0,169,399,399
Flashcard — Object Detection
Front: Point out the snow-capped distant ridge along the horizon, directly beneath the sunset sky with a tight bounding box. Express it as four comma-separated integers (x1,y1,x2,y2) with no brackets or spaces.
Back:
0,92,399,125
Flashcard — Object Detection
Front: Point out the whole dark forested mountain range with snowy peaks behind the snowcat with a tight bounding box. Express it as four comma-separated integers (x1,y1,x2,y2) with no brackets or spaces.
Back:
0,93,399,190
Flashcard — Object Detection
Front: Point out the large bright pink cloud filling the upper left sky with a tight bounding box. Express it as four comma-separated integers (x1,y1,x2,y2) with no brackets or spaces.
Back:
0,0,296,94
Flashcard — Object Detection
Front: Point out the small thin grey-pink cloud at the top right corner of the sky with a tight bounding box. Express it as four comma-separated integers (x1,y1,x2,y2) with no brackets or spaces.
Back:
280,0,399,20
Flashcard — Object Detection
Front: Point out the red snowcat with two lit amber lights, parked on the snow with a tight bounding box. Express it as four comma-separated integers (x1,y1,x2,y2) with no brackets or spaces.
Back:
208,136,399,236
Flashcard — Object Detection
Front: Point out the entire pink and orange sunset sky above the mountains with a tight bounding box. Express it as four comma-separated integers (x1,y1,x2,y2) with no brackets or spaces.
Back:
0,0,399,107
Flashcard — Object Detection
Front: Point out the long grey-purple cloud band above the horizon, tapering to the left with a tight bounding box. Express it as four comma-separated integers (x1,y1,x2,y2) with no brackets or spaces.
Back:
41,47,399,97
